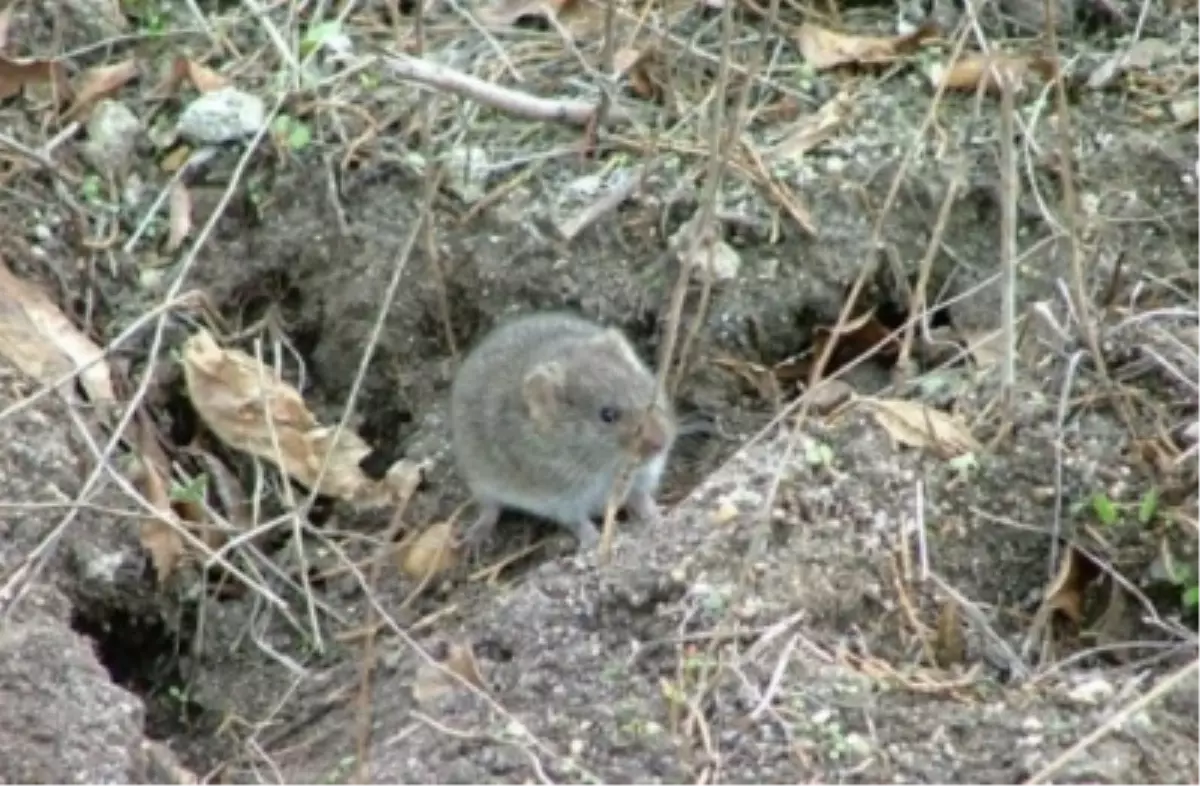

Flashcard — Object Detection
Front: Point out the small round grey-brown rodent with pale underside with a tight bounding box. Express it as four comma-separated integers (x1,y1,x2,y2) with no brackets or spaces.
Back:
450,311,678,548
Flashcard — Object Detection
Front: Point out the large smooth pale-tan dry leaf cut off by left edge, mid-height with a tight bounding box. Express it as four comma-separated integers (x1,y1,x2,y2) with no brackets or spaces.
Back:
0,259,116,410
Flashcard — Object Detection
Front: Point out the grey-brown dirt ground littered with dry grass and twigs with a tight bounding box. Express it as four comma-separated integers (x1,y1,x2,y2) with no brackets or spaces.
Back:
0,0,1200,785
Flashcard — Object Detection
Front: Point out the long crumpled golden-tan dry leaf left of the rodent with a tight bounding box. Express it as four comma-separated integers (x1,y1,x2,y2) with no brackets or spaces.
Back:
182,330,424,506
